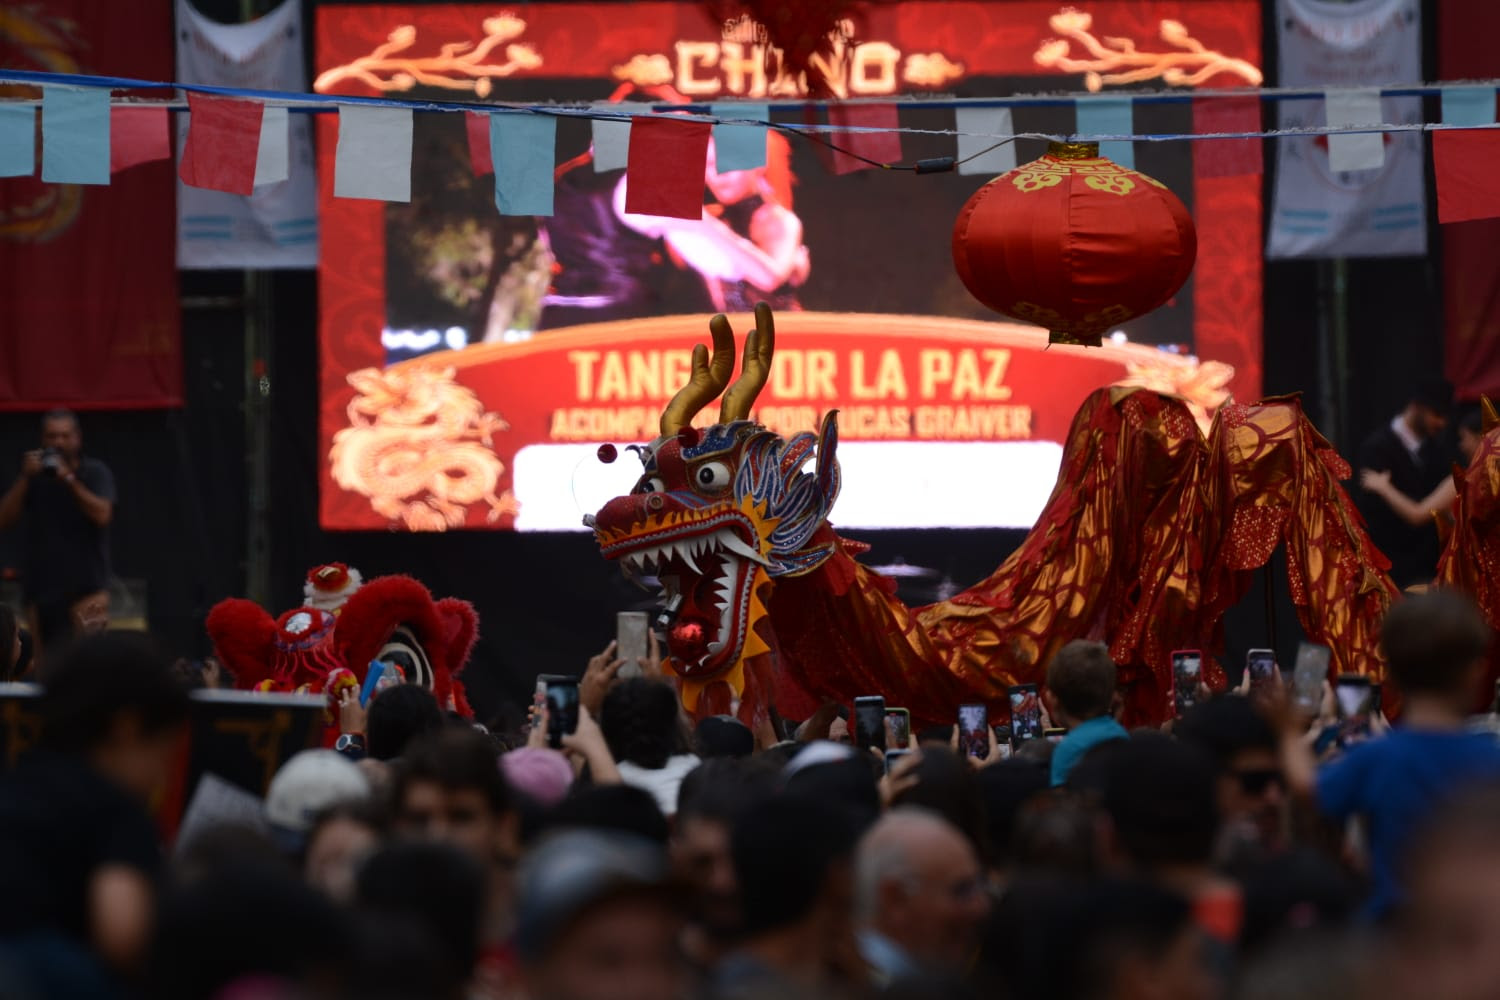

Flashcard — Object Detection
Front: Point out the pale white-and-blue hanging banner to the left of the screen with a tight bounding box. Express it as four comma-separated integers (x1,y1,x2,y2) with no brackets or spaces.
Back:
177,0,318,268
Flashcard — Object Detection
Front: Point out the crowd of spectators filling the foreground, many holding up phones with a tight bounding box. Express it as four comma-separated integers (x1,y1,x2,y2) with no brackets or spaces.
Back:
0,592,1500,1000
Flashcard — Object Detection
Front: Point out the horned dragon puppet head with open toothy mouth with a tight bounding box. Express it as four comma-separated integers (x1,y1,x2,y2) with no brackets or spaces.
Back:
588,303,839,712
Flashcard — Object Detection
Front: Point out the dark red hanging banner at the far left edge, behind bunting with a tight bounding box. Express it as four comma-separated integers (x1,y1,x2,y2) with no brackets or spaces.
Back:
0,0,182,409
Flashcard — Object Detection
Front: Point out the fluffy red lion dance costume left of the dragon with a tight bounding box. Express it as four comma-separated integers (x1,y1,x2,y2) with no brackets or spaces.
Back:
207,564,479,717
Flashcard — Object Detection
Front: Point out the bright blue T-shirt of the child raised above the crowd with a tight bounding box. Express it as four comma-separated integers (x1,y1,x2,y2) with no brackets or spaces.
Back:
1317,729,1500,918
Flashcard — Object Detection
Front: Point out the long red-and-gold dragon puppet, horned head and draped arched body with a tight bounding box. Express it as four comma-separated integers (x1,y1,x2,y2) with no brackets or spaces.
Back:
585,304,1397,723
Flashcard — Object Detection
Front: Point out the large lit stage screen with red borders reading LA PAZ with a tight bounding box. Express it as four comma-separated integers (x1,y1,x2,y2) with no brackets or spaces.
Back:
315,0,1262,531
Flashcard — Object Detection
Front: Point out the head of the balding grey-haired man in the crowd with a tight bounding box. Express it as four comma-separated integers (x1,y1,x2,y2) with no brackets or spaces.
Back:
855,808,990,982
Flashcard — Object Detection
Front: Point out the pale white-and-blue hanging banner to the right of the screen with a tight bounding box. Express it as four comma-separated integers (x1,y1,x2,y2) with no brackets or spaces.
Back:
1266,0,1427,258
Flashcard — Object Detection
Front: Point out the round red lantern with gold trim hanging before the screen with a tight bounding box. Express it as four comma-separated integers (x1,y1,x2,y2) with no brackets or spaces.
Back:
953,142,1199,346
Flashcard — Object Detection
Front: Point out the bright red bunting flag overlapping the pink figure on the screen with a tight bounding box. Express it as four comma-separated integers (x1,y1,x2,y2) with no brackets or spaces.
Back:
626,115,714,219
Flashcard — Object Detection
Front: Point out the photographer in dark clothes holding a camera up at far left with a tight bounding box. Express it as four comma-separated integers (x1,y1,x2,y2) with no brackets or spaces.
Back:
0,409,114,656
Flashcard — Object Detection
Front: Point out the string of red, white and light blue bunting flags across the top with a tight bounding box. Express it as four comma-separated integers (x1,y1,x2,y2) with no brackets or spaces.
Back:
0,69,1500,222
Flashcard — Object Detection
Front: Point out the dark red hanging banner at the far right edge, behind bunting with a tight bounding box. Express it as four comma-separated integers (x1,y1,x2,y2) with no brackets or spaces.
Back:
1437,0,1500,400
